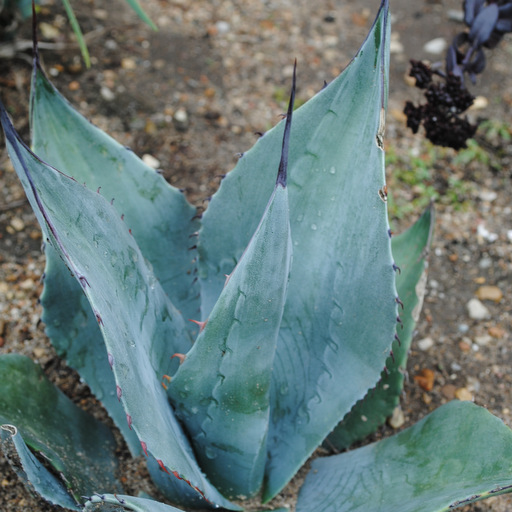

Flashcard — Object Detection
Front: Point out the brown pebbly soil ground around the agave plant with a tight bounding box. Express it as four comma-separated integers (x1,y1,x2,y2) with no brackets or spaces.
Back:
0,0,512,512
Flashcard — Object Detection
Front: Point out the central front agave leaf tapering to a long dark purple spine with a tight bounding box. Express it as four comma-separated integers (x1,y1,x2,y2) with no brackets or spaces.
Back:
169,75,295,498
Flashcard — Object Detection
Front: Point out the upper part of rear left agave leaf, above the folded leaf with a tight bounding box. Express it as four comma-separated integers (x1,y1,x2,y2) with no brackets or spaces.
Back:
30,62,200,334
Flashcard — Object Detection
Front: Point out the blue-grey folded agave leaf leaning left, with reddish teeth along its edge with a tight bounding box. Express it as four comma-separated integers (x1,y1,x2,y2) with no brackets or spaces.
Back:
0,106,237,509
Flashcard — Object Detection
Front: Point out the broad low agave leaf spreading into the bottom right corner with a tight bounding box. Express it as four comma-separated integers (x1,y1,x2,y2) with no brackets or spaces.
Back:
296,400,512,512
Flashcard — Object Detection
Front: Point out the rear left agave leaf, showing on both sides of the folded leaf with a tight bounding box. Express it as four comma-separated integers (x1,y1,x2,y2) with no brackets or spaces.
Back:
31,65,199,454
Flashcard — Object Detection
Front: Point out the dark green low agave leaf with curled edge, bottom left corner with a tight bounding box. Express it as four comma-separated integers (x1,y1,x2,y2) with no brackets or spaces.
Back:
0,354,121,510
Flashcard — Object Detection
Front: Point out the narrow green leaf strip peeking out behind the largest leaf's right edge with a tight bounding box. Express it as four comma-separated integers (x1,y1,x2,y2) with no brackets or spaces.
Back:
327,202,434,450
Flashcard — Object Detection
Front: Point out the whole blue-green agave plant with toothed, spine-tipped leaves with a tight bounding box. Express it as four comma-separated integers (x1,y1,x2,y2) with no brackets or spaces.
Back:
0,0,512,512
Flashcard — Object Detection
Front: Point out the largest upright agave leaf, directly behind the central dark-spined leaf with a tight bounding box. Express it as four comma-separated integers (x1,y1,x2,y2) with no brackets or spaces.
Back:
198,1,397,500
